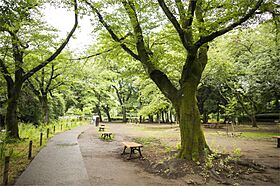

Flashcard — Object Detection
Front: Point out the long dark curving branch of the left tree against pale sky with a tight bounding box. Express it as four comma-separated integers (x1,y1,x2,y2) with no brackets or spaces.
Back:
23,0,78,81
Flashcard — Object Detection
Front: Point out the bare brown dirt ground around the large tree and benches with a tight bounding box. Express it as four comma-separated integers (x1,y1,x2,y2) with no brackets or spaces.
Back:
78,123,280,186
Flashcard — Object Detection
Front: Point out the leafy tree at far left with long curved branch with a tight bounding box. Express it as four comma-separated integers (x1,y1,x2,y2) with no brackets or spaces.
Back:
0,0,78,138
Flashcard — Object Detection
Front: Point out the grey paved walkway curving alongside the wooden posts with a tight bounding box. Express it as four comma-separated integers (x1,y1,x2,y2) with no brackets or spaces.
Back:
15,125,91,186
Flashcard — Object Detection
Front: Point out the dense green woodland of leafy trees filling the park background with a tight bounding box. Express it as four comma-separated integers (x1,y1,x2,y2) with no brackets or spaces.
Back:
0,0,280,159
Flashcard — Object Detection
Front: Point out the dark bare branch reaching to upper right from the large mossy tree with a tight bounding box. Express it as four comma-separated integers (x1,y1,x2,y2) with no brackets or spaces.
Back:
195,0,263,47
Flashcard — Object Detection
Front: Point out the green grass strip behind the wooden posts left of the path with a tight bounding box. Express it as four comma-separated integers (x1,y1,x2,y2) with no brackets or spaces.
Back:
0,120,88,185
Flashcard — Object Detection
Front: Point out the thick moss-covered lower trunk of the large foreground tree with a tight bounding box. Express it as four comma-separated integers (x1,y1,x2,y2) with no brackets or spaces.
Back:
176,79,208,160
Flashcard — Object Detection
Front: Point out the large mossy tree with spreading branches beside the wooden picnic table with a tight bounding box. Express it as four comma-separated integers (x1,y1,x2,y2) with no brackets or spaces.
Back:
84,0,263,160
